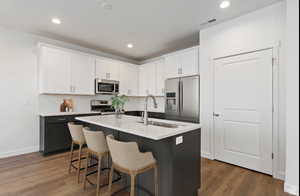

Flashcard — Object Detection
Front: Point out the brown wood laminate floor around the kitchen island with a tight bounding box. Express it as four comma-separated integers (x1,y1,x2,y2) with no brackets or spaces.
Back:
0,153,287,196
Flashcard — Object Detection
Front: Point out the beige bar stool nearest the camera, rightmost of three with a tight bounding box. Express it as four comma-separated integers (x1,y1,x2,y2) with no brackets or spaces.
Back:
106,135,158,196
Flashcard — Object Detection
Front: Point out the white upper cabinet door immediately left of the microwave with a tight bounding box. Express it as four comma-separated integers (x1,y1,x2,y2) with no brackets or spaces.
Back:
71,54,95,95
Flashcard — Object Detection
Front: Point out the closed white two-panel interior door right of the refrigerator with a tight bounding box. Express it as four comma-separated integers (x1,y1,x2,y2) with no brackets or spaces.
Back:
214,50,273,174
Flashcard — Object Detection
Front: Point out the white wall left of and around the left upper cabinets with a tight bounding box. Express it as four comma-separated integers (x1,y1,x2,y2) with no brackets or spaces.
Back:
0,27,139,158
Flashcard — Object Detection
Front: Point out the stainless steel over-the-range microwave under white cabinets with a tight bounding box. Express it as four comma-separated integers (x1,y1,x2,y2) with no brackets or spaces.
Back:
95,79,120,95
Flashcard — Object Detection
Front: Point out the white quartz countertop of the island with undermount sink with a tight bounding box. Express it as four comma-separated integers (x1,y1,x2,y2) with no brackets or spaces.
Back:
76,115,201,140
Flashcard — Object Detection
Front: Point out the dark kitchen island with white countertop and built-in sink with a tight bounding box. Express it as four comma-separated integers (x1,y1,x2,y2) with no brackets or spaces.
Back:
76,115,201,196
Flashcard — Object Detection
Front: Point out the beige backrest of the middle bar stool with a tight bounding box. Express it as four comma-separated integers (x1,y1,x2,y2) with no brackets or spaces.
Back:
83,128,109,154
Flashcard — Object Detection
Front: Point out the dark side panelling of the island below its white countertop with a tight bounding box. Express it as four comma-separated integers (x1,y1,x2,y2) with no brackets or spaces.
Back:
119,130,201,196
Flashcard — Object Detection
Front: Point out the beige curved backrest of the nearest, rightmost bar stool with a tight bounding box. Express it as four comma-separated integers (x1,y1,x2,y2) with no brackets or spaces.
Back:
106,135,140,169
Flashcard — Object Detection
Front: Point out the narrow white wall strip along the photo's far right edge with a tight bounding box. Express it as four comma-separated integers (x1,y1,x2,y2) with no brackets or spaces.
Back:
285,0,299,195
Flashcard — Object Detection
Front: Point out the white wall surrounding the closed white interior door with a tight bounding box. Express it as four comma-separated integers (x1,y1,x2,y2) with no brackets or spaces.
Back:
200,2,285,178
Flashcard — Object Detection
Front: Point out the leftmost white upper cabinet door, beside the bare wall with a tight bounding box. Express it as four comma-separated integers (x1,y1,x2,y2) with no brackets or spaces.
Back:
39,47,71,94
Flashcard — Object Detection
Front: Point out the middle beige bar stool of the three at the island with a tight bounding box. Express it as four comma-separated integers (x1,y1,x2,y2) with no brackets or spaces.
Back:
83,128,109,196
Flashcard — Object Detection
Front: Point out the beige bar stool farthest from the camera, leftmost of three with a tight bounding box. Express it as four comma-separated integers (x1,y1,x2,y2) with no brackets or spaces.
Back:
68,122,86,183
